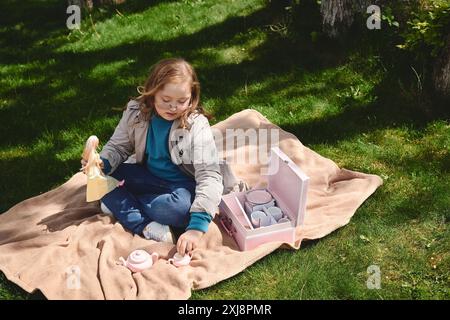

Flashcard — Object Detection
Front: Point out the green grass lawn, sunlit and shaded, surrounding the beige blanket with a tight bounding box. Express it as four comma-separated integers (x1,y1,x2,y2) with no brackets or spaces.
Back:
0,0,450,299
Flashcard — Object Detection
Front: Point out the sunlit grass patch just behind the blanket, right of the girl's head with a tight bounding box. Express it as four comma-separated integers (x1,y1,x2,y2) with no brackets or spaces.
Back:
219,61,375,126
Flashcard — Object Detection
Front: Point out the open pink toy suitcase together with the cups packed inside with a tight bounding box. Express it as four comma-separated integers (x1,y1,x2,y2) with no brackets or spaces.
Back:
219,147,309,251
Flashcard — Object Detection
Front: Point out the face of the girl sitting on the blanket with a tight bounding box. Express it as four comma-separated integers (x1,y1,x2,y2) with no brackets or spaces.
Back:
155,82,191,121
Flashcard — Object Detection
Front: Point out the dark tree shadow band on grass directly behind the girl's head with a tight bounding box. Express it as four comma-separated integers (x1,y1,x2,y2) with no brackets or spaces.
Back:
0,1,348,145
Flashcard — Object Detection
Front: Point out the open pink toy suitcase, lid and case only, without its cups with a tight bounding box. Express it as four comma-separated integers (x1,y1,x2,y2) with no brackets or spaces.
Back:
219,147,309,251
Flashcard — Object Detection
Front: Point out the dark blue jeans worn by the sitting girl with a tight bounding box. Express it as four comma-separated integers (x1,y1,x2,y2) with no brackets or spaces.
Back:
101,163,196,235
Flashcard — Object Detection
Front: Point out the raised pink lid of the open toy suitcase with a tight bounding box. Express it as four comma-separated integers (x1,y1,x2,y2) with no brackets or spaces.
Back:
266,147,309,226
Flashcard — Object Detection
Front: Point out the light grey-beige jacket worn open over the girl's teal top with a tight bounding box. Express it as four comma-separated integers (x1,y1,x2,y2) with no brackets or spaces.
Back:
100,100,248,217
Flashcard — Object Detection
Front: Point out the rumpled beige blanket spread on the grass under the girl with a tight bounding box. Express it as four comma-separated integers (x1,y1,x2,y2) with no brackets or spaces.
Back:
0,110,382,299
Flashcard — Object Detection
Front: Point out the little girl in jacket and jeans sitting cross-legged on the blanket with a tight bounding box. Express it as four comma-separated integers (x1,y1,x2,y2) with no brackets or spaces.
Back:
82,59,224,255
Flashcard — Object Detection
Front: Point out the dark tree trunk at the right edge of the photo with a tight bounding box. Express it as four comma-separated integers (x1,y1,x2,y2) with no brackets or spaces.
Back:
433,34,450,101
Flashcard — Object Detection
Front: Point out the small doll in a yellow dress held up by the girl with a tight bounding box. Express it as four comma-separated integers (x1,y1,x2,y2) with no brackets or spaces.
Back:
83,136,119,202
